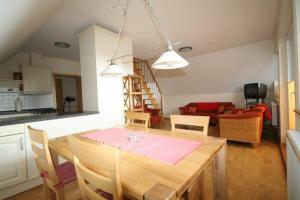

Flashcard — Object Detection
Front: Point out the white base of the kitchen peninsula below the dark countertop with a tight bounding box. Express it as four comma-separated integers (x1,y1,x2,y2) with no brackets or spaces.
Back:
0,114,102,199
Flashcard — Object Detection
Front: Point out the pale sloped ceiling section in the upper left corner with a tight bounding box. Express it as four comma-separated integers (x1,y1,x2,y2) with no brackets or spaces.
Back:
0,0,61,63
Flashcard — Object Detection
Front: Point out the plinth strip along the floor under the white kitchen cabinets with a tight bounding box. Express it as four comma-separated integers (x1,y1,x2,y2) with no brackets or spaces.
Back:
0,178,43,199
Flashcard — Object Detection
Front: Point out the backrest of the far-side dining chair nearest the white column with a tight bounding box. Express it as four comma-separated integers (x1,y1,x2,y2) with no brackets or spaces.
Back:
125,112,150,128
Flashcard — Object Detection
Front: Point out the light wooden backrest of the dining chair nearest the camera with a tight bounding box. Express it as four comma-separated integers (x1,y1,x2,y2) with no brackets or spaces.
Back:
69,136,122,200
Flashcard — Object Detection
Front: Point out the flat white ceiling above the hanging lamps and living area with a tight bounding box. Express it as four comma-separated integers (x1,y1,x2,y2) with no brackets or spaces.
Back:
5,0,280,60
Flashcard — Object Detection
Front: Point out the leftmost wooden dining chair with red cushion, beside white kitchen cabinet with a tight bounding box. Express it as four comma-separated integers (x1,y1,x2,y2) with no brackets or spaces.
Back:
27,126,79,200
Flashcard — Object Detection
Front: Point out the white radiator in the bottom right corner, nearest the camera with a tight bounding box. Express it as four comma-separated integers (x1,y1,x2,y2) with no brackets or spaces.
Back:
286,131,300,200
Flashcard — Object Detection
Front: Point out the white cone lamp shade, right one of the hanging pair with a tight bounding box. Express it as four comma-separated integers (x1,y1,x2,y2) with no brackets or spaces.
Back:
152,49,189,69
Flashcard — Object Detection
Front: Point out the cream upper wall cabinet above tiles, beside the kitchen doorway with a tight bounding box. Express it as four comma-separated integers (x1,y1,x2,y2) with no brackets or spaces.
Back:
23,65,52,94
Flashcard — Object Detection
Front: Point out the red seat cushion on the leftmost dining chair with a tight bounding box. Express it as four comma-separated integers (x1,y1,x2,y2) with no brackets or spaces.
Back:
41,162,76,189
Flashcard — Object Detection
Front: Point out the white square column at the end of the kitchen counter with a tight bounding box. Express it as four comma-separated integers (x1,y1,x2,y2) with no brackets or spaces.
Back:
79,26,133,125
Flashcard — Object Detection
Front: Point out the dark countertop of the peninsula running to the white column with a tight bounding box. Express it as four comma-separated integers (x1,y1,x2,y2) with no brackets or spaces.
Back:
0,111,99,126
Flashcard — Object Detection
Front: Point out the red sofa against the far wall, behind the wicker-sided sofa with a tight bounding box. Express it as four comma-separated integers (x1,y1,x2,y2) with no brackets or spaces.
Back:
179,102,235,124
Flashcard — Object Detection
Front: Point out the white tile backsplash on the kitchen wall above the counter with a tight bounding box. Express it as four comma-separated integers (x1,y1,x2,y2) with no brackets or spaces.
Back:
0,92,53,111
